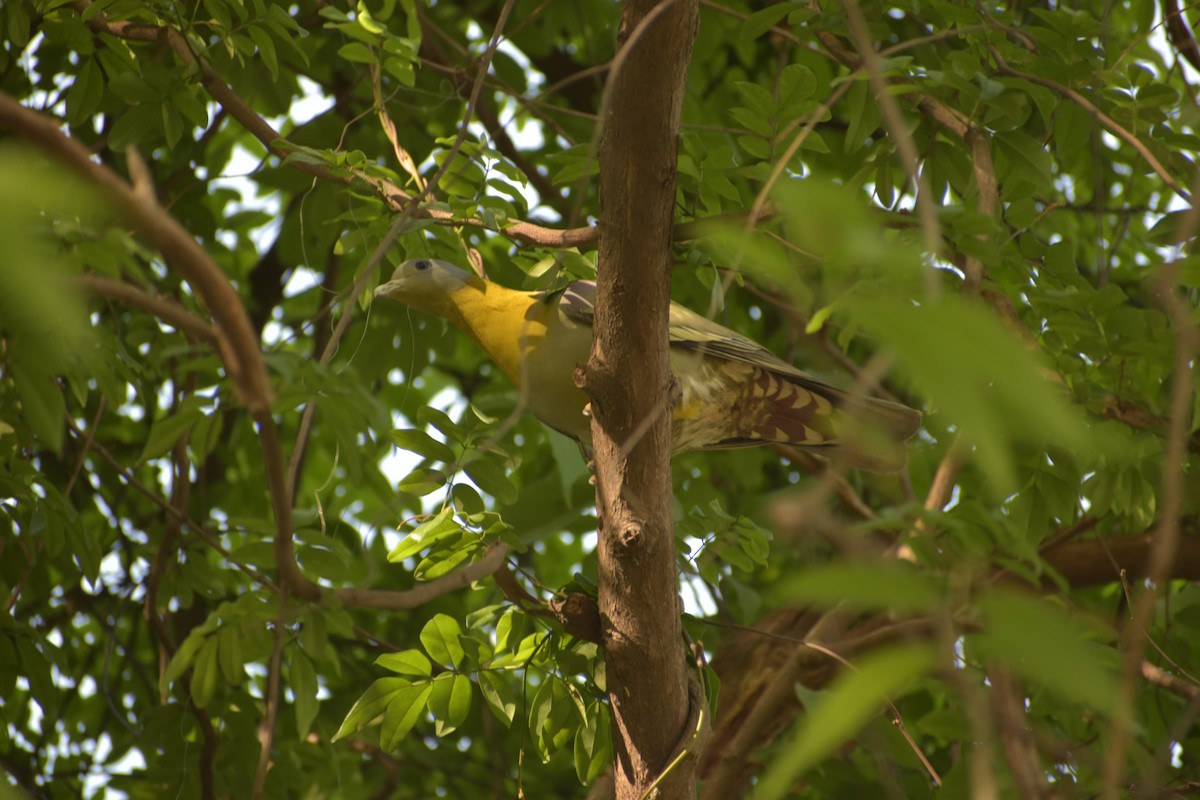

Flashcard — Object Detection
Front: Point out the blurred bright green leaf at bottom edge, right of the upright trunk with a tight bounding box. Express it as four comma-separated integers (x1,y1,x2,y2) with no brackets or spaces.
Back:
754,646,936,800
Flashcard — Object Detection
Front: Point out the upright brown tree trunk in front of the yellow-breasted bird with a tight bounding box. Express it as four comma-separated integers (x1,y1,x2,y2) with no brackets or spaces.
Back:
581,0,702,800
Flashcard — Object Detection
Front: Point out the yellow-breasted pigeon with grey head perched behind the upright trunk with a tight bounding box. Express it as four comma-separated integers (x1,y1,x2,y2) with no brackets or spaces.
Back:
374,258,922,473
